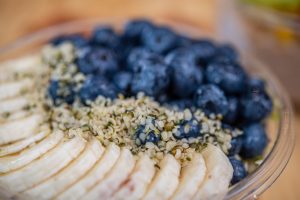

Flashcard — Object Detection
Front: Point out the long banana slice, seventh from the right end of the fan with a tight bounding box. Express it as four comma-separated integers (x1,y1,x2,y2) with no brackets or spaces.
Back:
25,139,104,199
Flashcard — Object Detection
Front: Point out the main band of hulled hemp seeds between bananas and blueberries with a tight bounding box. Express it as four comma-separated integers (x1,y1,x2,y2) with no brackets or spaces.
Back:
51,94,241,163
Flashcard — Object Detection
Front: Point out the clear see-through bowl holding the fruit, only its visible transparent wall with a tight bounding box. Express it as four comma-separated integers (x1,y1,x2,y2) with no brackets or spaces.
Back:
0,18,295,199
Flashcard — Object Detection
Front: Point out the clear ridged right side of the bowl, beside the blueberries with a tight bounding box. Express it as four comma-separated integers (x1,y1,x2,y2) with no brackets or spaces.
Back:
226,52,295,199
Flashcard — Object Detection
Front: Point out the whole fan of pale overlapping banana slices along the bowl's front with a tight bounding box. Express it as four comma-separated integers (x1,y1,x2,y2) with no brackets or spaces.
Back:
0,56,233,200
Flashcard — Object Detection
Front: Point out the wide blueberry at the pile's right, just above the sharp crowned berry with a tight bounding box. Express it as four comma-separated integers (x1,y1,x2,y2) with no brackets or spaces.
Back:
205,62,247,94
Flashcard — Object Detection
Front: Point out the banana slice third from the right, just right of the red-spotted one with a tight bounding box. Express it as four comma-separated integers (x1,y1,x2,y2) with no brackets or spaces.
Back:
143,154,181,200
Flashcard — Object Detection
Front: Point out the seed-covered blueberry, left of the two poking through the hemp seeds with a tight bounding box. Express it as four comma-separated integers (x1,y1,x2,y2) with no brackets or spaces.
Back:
135,125,160,145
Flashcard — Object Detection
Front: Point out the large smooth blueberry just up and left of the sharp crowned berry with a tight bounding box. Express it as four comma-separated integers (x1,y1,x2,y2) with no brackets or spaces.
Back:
169,48,203,98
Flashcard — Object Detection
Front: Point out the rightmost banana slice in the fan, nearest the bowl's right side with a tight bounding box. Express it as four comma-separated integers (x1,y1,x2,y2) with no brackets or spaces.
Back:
193,144,233,200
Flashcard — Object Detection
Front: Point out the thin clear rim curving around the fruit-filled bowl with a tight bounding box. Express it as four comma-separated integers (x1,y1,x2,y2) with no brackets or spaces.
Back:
0,17,295,199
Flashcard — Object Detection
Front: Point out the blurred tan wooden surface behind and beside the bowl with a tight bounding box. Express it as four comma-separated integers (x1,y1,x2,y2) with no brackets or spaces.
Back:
0,0,300,200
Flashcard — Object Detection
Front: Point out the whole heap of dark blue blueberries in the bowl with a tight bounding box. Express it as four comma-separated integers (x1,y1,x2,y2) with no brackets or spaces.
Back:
49,20,272,183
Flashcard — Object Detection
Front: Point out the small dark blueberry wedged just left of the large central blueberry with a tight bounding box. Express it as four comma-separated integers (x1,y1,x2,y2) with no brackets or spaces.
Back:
113,71,132,94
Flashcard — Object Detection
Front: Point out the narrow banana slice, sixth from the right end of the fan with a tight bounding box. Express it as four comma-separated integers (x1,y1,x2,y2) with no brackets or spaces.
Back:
56,143,120,200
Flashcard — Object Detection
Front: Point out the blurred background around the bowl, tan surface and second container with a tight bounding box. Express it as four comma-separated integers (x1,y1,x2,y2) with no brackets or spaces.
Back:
0,0,300,200
